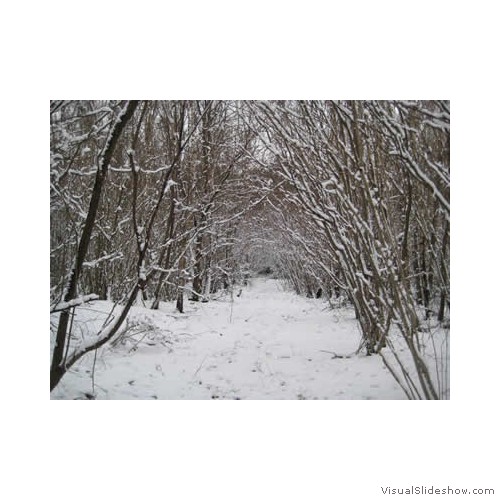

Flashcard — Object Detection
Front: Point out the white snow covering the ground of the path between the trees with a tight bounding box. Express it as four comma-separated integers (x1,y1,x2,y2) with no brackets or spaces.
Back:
51,278,405,400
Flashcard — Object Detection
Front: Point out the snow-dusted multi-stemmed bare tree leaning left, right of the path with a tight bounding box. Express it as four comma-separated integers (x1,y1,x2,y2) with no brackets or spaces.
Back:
250,101,449,399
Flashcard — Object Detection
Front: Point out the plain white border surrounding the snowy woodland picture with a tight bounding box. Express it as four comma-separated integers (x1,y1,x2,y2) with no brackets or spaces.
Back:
0,0,499,499
